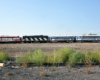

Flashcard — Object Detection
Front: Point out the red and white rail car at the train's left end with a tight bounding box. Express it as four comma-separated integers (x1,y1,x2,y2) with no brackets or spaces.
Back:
0,36,22,43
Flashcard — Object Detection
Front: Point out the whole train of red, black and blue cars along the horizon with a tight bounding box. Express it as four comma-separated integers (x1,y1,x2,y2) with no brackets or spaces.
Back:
0,34,100,43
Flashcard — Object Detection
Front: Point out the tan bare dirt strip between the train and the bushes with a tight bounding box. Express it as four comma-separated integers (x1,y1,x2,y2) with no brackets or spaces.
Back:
0,43,100,57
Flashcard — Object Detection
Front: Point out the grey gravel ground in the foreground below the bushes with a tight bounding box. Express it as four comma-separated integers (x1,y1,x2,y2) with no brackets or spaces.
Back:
0,66,100,80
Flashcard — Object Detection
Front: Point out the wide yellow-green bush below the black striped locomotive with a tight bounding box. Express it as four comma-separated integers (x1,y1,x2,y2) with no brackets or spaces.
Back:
16,50,46,66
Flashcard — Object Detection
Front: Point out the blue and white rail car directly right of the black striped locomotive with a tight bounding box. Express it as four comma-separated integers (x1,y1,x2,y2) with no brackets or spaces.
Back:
49,36,75,42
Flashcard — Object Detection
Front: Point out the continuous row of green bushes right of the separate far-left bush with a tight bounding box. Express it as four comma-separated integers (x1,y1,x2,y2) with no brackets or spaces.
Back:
10,48,100,67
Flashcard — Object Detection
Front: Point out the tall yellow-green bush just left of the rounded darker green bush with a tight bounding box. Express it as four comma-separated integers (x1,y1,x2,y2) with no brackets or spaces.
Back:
58,48,75,62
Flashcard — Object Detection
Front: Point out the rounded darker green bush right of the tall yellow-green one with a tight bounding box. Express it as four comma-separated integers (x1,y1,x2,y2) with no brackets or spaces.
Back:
68,52,85,66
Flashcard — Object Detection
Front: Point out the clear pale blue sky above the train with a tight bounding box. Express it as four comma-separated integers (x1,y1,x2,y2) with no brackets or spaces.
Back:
0,0,100,36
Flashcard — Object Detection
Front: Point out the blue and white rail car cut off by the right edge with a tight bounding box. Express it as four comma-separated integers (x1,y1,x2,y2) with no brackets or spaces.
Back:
76,34,100,42
